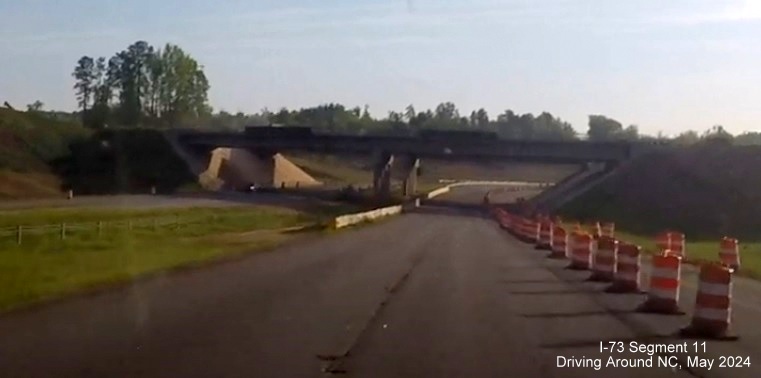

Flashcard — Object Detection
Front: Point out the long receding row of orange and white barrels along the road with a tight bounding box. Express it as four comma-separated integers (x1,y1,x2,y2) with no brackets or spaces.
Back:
492,208,740,339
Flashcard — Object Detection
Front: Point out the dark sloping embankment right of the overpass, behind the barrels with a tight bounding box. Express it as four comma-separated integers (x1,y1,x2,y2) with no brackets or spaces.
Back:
561,142,761,240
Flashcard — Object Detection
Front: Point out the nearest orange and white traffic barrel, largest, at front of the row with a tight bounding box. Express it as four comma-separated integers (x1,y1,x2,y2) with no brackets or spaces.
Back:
681,263,737,339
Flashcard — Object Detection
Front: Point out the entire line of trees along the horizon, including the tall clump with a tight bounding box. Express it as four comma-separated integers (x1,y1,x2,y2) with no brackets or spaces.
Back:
68,41,761,144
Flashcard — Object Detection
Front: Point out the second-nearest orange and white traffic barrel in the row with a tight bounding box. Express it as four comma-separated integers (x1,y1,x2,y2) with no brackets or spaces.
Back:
637,250,684,315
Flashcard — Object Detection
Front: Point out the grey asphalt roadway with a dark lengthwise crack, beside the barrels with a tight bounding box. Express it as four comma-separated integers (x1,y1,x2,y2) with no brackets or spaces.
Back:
0,188,761,378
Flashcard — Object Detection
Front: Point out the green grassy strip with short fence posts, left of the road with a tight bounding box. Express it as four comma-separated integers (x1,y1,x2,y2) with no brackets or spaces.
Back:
0,207,332,310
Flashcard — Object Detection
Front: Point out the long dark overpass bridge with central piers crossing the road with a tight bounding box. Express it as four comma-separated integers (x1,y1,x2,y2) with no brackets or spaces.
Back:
172,126,654,196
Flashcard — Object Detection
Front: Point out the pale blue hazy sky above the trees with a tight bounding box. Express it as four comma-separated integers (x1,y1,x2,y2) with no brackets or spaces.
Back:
0,0,761,134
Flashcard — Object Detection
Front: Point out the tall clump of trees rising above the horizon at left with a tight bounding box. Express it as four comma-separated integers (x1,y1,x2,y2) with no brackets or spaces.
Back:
72,41,211,128
